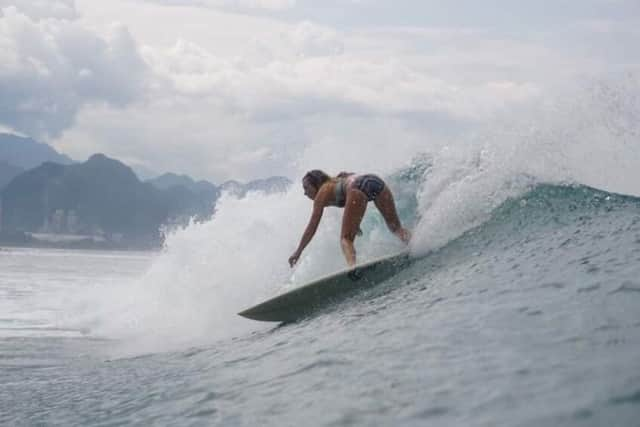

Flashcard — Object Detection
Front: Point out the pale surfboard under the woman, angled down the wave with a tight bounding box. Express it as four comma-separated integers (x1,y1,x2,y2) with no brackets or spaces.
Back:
238,252,411,322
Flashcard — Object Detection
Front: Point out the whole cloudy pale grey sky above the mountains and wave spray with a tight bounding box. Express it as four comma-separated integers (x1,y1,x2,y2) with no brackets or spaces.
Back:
0,0,640,183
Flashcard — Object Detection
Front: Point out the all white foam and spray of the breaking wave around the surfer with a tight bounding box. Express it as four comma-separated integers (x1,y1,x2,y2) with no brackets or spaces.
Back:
74,74,640,352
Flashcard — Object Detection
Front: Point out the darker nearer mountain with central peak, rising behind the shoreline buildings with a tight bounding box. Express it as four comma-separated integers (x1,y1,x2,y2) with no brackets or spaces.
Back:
2,154,215,247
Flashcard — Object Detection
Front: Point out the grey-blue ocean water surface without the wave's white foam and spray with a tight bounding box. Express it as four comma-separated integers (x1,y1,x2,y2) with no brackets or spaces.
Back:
0,185,640,426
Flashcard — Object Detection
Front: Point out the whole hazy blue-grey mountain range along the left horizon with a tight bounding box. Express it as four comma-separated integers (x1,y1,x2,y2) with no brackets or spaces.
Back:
0,133,290,249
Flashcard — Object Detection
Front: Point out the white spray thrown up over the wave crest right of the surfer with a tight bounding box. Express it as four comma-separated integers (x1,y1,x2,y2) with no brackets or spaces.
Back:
412,74,640,253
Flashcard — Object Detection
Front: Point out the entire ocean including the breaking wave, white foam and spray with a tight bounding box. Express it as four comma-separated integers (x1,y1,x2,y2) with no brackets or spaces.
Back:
0,76,640,427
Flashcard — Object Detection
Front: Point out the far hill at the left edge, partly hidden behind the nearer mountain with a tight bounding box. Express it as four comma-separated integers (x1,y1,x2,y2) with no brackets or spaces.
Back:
0,133,73,169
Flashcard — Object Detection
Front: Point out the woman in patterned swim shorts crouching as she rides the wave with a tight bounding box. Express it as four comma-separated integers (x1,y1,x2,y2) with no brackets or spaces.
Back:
289,169,411,267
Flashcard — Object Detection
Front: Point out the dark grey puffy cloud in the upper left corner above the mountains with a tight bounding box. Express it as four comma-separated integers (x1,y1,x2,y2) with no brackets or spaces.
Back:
0,2,147,137
